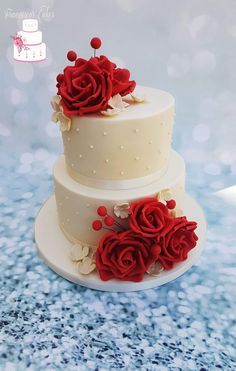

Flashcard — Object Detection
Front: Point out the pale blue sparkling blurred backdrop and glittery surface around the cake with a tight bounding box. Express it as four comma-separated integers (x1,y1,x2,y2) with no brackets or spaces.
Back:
0,0,236,371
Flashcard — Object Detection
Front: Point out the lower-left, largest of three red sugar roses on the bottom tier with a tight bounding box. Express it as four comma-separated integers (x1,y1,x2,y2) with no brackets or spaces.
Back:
96,230,161,282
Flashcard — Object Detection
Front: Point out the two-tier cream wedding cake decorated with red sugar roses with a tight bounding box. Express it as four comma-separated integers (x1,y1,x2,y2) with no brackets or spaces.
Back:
36,38,206,291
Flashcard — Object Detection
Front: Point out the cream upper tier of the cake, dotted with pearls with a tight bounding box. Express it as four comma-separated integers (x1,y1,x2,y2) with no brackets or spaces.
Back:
62,87,174,189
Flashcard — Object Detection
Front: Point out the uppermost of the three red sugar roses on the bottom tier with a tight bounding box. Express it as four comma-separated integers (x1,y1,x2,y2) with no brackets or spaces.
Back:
130,198,174,240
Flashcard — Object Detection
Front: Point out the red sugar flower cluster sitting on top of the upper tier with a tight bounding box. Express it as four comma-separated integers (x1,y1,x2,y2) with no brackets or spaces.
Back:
57,51,136,116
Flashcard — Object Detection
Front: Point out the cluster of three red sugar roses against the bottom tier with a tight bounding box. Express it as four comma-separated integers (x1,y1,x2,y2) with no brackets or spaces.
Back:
96,198,198,281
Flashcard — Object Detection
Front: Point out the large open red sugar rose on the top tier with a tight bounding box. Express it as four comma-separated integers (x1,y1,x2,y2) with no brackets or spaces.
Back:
57,58,112,116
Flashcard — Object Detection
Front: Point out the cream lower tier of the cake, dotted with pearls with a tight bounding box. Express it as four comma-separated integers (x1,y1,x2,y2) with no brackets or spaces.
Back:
53,151,185,248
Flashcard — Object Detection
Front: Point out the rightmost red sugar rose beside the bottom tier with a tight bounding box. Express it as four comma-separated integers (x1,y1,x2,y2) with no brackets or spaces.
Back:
159,216,198,269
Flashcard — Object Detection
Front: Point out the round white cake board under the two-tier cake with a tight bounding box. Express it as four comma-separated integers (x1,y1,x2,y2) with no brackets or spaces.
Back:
35,194,206,292
